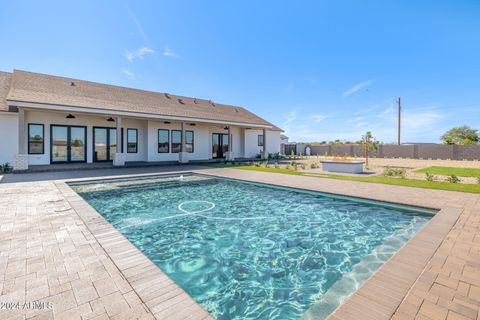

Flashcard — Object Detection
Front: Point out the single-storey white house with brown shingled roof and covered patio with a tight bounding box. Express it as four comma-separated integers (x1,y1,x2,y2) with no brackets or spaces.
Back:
0,70,282,170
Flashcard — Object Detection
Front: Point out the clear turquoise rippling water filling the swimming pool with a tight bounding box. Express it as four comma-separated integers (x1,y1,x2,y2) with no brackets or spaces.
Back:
71,175,432,319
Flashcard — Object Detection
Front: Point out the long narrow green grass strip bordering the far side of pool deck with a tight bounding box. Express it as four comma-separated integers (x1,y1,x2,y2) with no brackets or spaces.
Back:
200,163,480,193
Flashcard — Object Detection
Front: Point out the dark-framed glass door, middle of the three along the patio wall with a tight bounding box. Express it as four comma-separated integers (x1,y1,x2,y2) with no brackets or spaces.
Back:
93,127,117,162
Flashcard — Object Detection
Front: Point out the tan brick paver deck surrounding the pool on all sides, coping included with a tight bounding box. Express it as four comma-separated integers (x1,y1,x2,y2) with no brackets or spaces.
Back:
0,166,480,320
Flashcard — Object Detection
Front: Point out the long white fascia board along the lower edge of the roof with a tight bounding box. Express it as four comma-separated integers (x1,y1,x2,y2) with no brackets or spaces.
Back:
7,100,272,129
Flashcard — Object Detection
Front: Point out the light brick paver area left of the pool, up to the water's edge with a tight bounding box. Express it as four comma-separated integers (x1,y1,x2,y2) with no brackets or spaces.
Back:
0,182,210,320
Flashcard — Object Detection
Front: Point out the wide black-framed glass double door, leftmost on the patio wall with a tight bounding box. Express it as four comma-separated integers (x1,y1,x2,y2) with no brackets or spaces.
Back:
50,125,87,163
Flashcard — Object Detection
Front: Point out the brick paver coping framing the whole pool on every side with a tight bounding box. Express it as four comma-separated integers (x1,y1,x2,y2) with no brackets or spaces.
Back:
56,167,477,320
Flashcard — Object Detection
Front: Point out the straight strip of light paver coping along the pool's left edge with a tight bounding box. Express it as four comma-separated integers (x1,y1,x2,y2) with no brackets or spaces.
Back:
54,179,214,320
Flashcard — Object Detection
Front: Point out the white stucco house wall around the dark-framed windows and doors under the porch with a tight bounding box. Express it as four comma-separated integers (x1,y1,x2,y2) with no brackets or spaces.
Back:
5,110,280,165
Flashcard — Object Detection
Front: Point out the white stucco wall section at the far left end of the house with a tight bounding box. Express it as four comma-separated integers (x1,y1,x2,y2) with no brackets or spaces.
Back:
0,112,18,165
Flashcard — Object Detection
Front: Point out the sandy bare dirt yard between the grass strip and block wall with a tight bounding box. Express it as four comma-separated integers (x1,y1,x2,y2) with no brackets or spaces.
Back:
287,156,480,184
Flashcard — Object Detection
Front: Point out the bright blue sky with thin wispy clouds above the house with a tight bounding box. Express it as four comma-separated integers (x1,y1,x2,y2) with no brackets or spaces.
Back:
0,0,480,142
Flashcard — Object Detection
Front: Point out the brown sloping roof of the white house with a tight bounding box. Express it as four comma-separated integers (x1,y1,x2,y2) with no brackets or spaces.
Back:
0,70,282,131
